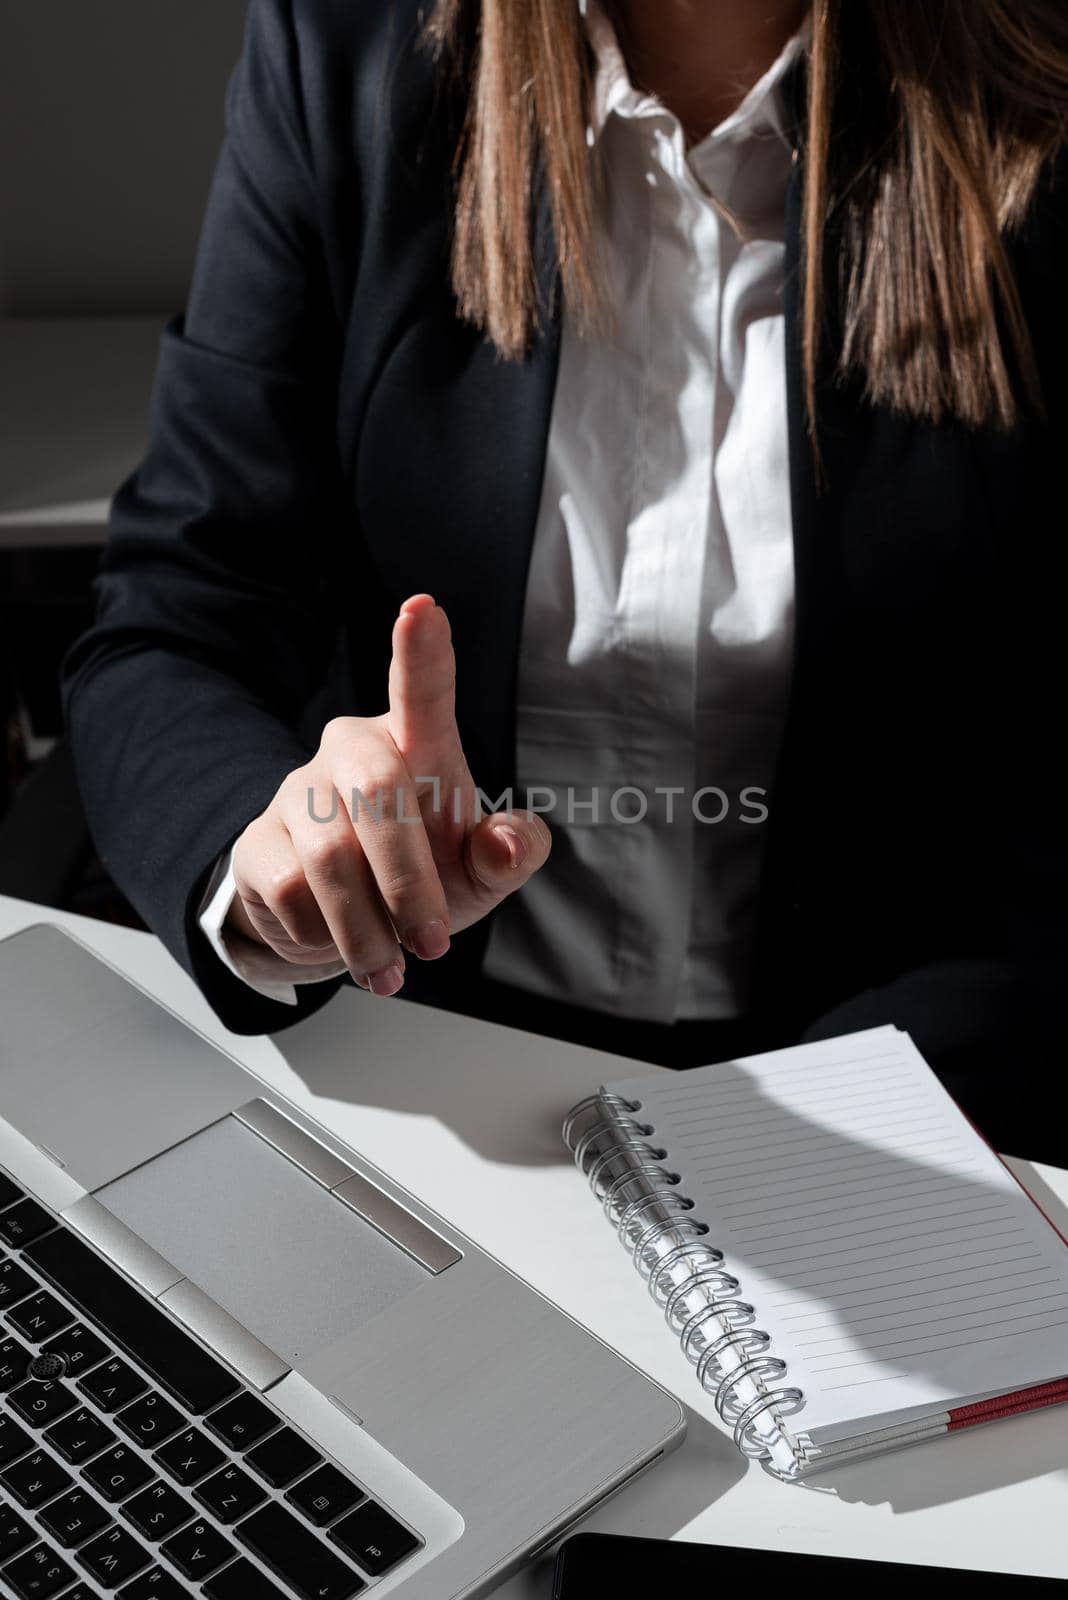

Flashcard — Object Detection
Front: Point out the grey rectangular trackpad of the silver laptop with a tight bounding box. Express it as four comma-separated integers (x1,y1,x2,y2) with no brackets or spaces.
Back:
96,1117,430,1366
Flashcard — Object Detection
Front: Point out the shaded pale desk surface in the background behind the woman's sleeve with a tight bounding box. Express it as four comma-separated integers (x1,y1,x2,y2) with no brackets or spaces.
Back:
0,317,163,549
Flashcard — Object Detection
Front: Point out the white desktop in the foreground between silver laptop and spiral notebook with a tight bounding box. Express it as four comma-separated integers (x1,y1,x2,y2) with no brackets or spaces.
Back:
0,898,1068,1600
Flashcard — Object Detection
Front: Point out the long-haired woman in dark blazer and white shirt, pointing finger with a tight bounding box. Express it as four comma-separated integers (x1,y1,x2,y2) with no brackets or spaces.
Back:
66,0,1068,1154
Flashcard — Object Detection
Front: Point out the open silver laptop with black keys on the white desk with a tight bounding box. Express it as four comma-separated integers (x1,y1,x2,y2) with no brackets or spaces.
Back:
0,926,684,1600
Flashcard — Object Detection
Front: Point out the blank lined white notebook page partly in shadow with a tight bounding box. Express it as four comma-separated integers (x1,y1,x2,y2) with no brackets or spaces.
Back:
609,1027,1068,1440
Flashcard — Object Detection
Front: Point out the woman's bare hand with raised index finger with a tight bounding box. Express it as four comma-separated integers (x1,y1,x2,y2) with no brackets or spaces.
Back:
227,595,550,995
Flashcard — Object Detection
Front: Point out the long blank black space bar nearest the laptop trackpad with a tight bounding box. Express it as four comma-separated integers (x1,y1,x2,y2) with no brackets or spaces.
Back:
24,1213,238,1414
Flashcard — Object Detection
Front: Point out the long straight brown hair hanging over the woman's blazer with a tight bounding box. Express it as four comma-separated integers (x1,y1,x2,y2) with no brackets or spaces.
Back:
428,0,1068,444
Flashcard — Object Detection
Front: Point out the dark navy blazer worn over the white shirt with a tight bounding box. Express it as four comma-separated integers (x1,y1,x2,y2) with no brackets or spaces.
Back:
67,0,1068,1152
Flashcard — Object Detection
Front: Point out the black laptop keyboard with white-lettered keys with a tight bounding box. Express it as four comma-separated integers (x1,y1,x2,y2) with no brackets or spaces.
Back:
0,1173,422,1600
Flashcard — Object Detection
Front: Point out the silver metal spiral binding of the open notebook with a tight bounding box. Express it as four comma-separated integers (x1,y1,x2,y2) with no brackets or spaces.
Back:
563,1090,804,1475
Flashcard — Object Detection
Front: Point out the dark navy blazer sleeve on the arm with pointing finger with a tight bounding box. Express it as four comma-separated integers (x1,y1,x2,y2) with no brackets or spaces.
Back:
64,0,360,1034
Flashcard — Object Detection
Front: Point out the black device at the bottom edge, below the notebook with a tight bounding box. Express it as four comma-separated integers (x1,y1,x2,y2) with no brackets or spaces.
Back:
553,1533,1068,1600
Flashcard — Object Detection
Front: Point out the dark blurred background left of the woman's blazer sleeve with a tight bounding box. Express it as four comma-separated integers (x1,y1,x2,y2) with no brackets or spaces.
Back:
0,0,246,920
